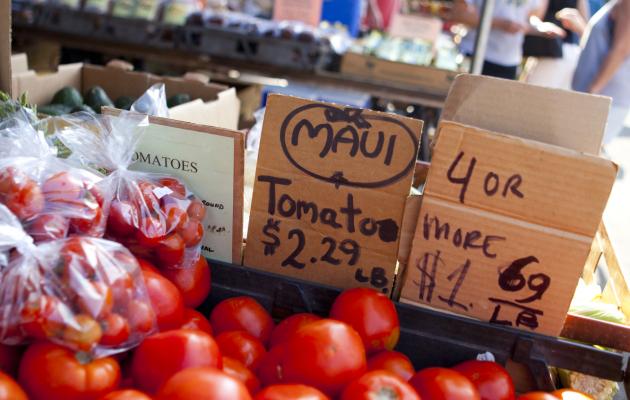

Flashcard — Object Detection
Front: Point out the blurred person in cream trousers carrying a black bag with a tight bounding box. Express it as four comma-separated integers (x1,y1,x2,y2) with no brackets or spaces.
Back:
523,0,590,90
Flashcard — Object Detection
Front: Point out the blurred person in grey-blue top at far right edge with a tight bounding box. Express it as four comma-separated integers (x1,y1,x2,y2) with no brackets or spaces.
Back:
572,0,630,144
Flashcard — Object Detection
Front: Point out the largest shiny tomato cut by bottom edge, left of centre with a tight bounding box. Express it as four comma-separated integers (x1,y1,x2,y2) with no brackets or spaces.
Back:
156,367,251,400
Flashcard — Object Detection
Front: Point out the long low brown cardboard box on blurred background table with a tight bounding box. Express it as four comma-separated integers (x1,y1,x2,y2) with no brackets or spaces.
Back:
341,52,458,95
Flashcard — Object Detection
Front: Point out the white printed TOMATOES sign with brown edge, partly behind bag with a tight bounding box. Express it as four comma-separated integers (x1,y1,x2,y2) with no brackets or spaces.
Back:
104,108,244,263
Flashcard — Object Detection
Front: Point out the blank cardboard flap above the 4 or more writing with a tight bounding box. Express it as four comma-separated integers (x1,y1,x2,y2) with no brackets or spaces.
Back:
442,75,611,154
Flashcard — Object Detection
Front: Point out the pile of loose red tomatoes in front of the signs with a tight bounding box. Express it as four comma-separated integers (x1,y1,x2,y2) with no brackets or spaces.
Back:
0,284,590,400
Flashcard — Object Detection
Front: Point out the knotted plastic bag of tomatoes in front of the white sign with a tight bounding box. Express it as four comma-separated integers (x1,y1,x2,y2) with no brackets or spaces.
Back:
56,113,205,268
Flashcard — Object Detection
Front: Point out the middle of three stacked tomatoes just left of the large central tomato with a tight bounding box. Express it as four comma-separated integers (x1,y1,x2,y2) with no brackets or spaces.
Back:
216,331,266,371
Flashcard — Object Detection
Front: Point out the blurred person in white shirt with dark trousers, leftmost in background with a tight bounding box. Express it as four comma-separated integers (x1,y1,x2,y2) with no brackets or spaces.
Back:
450,0,565,79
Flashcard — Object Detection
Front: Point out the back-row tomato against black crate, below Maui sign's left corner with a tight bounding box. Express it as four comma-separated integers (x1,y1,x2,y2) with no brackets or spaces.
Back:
210,296,274,344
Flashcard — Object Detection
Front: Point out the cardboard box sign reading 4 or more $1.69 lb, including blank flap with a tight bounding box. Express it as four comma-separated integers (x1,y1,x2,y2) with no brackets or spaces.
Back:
401,75,617,335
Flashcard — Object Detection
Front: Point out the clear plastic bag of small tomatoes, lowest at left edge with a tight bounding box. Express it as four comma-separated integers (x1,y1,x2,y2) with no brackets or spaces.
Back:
0,205,157,357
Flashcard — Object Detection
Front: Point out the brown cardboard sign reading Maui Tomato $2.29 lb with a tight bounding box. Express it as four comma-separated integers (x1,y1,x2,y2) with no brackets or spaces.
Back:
245,95,422,294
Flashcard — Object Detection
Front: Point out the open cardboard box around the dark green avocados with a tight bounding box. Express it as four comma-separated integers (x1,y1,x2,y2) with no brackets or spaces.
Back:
12,63,240,129
